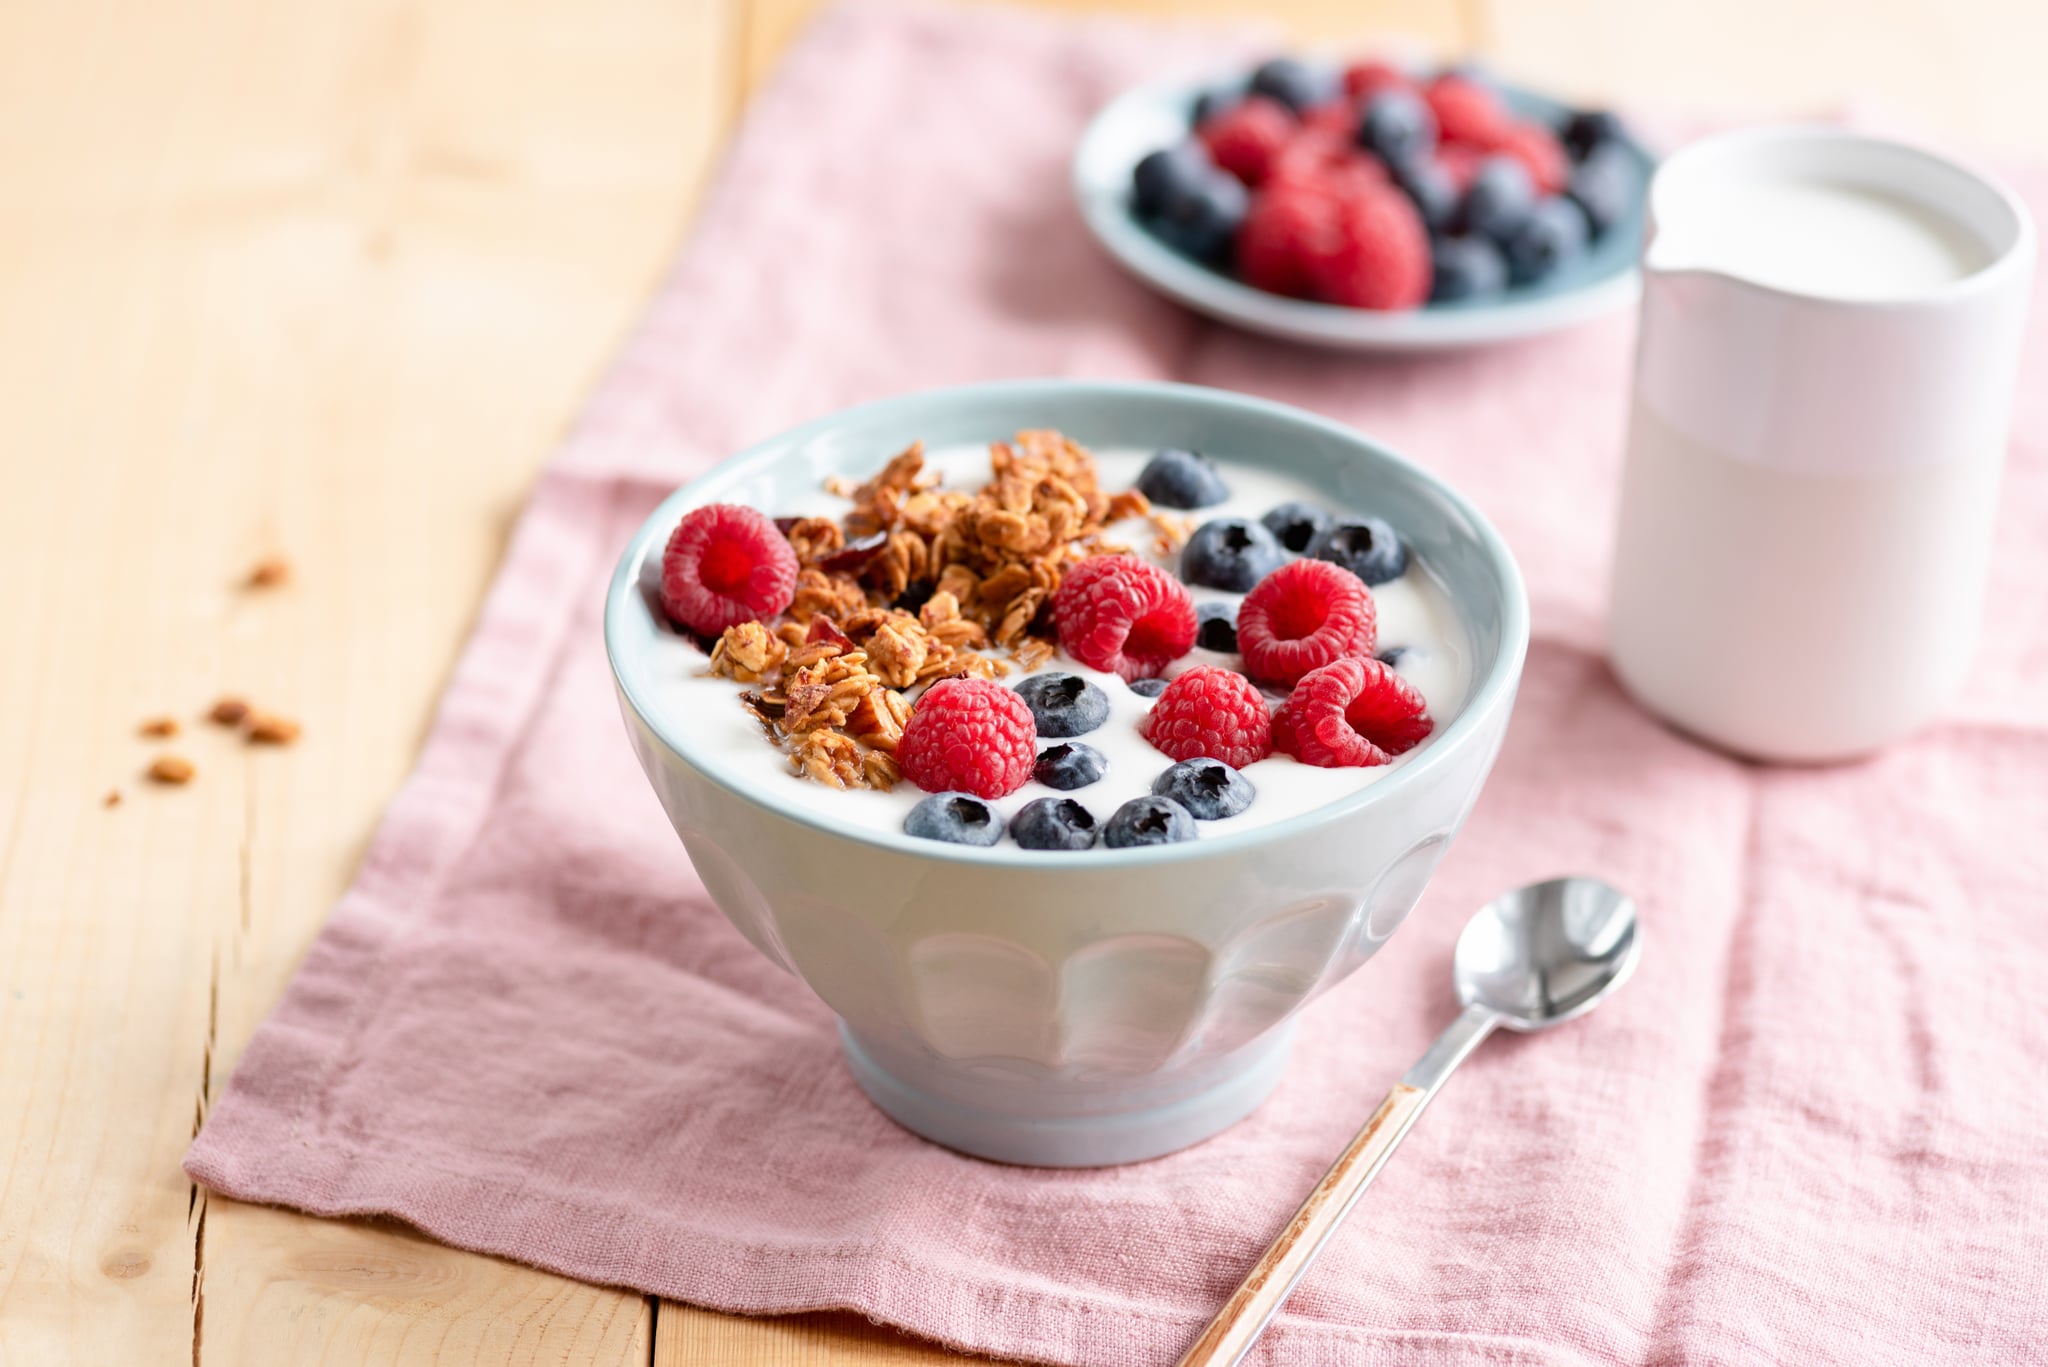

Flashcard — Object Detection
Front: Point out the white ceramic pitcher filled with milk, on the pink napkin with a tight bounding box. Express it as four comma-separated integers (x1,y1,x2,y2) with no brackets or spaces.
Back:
1610,127,2036,760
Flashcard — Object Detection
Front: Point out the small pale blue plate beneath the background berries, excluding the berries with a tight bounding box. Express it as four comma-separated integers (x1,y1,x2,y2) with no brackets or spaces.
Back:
1073,72,1655,353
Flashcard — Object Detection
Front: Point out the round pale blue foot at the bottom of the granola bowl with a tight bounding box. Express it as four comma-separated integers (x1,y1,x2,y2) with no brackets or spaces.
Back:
840,1021,1294,1168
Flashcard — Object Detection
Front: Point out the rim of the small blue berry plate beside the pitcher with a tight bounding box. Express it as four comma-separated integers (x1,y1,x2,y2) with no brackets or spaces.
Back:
1069,70,1657,353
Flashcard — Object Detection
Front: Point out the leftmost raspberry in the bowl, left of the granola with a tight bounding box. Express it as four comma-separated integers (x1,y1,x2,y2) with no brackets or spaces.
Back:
662,502,797,635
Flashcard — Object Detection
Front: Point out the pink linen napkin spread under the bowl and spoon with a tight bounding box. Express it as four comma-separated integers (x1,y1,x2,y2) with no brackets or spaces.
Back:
186,6,2048,1367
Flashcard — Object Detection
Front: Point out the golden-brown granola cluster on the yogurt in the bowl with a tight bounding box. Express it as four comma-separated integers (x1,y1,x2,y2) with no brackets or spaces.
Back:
711,430,1146,789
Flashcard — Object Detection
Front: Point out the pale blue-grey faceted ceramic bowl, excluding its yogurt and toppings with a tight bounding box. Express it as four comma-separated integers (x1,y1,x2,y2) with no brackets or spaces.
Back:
604,381,1528,1166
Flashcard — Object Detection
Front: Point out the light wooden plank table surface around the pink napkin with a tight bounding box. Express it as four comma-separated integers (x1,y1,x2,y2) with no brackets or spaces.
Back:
0,0,2048,1367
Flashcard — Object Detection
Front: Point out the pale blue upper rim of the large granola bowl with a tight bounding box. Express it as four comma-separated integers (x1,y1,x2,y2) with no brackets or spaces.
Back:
604,377,1530,871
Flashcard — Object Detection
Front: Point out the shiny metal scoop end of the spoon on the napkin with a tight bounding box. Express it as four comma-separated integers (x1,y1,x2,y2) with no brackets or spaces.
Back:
1452,877,1640,1031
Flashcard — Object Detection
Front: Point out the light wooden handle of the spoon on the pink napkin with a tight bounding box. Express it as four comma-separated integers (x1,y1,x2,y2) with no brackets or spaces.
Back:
1180,1082,1430,1367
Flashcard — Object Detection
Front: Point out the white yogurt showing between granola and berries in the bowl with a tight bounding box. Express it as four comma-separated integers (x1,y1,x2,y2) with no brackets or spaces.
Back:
651,447,1470,832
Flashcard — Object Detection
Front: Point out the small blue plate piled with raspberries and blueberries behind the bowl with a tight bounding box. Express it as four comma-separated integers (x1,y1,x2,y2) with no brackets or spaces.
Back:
1073,57,1655,353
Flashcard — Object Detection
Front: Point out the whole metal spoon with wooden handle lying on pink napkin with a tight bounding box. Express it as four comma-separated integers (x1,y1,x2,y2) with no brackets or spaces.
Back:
1180,877,1638,1367
